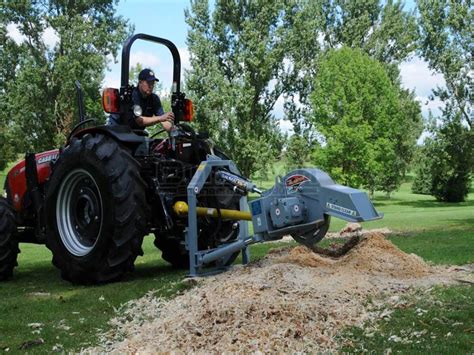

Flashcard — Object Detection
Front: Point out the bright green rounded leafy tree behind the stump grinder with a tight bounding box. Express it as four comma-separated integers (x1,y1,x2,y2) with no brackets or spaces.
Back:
311,47,421,193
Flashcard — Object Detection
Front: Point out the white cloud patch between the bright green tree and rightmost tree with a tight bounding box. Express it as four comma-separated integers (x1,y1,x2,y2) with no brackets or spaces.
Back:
400,57,445,97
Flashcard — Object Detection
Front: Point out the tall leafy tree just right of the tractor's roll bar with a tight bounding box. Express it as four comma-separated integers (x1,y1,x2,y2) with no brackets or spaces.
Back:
185,0,288,176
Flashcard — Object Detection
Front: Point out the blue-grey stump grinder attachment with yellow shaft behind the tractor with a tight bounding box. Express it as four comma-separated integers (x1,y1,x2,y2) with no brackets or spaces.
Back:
174,159,383,276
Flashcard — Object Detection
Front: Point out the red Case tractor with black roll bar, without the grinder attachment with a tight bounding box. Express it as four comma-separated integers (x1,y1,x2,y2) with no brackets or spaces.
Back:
0,34,241,283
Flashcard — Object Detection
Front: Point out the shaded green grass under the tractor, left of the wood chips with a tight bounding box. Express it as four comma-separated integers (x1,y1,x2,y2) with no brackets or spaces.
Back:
0,238,186,353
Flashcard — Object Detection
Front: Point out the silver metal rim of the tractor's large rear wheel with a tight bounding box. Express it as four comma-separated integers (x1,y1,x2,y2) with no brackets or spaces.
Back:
56,169,103,256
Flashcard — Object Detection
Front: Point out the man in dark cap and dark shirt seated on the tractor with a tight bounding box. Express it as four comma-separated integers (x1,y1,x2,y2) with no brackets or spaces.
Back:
107,69,174,132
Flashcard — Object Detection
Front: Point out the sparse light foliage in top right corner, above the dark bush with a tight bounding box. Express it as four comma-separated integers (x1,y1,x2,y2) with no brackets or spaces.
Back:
418,0,474,128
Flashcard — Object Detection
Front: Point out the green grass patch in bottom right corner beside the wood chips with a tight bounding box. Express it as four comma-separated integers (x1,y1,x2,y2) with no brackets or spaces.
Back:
342,286,474,354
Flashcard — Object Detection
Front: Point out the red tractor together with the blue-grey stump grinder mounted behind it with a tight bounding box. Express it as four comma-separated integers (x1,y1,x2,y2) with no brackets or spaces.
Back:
0,34,383,283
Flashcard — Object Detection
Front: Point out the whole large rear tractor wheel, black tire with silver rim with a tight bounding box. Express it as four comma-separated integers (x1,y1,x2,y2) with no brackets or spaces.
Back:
46,134,146,284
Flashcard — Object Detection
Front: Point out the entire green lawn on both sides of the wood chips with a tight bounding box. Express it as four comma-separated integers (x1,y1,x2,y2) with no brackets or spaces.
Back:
0,163,474,353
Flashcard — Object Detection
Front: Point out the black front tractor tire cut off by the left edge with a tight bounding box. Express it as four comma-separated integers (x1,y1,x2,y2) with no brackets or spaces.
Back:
0,197,20,281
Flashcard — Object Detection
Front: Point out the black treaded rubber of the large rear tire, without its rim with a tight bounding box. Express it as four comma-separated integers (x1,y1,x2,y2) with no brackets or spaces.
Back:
46,135,146,284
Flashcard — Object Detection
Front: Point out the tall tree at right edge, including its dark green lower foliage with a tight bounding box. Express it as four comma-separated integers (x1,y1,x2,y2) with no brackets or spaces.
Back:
418,0,474,202
